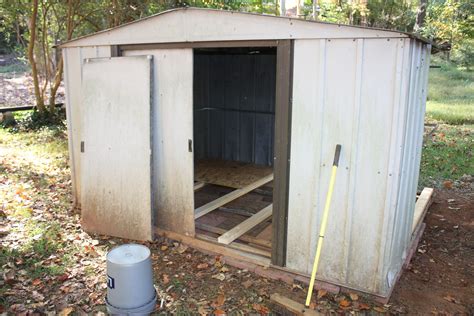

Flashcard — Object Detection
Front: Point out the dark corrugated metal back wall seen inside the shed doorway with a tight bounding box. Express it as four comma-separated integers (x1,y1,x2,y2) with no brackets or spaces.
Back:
194,48,276,165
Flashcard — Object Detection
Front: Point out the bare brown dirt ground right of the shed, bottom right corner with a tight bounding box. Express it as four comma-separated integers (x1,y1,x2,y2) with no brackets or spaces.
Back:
390,190,474,315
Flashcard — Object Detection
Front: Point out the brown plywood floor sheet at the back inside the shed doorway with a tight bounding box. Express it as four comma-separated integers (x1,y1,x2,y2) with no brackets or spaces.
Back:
194,160,273,189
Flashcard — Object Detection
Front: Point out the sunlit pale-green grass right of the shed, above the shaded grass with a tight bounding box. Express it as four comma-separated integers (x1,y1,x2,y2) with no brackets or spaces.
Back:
426,58,474,125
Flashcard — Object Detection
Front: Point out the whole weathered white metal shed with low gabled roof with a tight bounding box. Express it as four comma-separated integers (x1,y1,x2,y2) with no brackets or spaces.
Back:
61,8,430,297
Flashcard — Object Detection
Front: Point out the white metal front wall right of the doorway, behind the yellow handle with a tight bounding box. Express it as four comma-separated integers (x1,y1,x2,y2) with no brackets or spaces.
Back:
287,39,430,295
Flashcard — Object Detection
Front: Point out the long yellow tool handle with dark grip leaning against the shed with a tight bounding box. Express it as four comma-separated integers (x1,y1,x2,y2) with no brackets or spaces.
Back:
305,144,341,307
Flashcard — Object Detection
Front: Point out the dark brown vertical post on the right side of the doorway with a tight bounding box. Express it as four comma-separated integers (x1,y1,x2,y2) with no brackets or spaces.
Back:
272,40,294,267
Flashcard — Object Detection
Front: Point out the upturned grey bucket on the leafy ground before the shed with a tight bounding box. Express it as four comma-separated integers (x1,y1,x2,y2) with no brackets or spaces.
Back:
105,244,156,315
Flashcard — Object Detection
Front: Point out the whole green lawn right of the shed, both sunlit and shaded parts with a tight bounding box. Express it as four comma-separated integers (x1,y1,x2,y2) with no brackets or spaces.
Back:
419,58,474,188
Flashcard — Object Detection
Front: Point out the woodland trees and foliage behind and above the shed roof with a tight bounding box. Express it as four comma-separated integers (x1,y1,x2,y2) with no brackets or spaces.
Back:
0,0,474,113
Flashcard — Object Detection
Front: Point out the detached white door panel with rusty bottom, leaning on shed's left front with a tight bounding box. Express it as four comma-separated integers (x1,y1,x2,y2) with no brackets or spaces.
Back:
81,56,154,240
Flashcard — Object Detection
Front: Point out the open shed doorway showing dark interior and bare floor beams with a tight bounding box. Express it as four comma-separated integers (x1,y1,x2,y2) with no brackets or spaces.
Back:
193,47,277,258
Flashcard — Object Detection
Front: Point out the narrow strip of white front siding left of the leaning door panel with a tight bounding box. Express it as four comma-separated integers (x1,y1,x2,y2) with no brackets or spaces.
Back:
62,46,111,205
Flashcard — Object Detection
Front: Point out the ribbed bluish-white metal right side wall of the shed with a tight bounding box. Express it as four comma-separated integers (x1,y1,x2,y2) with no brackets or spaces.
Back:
383,40,431,287
